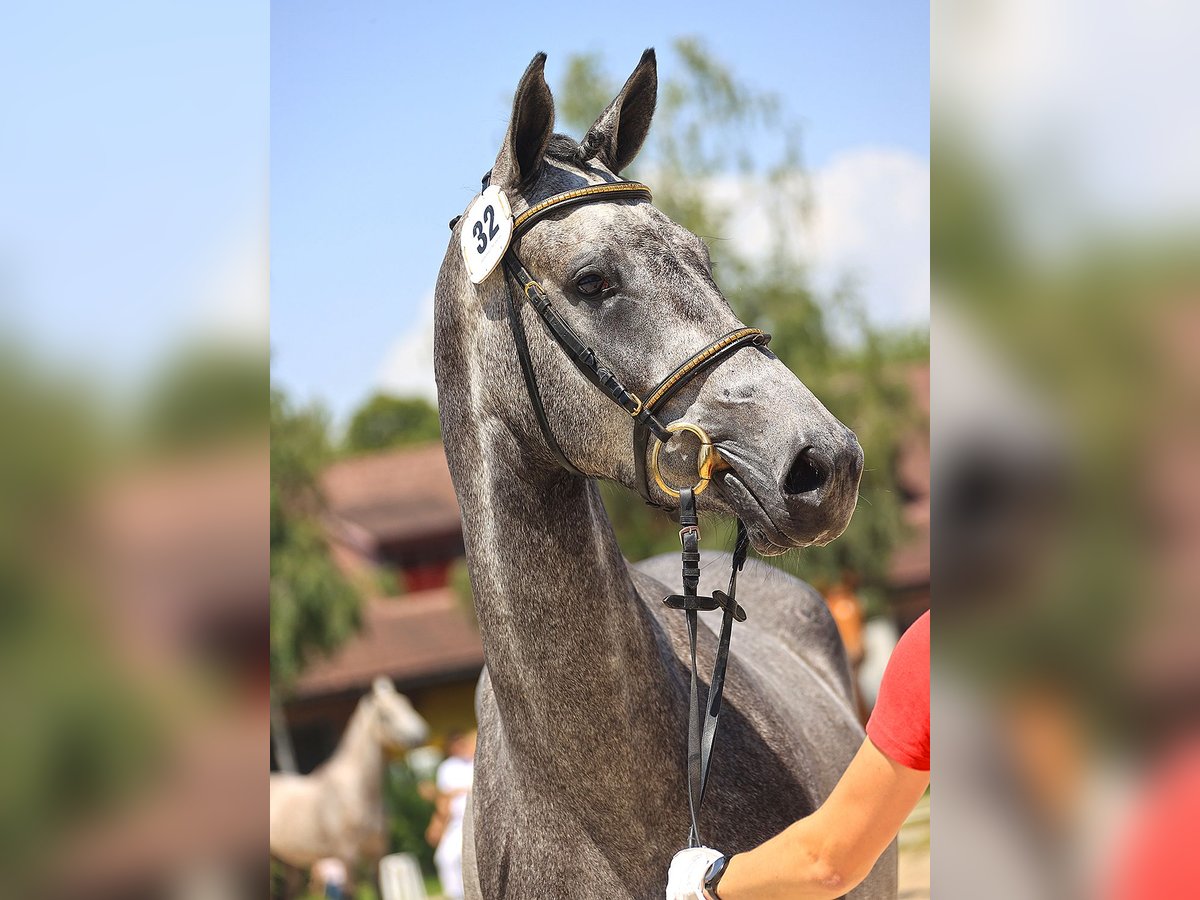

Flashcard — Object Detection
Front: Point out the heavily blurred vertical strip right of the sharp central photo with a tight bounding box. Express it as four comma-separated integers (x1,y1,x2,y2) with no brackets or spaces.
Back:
931,0,1200,898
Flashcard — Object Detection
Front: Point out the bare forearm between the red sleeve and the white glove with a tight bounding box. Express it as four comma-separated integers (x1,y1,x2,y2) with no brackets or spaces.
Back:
718,738,929,900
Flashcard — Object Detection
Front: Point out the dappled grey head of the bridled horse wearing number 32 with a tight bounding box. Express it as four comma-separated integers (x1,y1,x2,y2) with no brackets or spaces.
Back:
437,50,863,554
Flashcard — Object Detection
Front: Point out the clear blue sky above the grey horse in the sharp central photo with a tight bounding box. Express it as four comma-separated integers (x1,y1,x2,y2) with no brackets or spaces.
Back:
271,0,929,415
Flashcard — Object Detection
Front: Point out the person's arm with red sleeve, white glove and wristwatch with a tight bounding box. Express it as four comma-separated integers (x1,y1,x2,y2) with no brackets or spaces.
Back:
666,612,929,900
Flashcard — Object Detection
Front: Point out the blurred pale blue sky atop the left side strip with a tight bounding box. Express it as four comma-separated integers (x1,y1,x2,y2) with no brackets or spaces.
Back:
0,0,270,391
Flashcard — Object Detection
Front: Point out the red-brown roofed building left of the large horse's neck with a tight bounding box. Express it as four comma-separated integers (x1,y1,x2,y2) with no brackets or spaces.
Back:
284,444,484,772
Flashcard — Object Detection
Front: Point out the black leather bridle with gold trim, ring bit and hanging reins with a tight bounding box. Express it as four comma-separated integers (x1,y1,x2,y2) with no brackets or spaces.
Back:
450,176,770,847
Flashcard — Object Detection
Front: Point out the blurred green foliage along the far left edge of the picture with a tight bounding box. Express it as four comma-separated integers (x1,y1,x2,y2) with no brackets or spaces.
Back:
0,348,159,896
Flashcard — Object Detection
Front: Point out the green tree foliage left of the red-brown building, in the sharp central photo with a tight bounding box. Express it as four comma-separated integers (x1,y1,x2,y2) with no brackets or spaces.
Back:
271,390,361,694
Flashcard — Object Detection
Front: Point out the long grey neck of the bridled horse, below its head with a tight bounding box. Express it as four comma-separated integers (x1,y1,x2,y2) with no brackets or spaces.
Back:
438,340,674,772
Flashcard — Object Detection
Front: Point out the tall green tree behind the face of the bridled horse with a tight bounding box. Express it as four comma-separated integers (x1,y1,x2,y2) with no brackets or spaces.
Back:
558,38,929,609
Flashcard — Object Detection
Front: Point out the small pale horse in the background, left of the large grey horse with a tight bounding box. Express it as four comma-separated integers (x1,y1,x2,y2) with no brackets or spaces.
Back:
271,676,430,872
